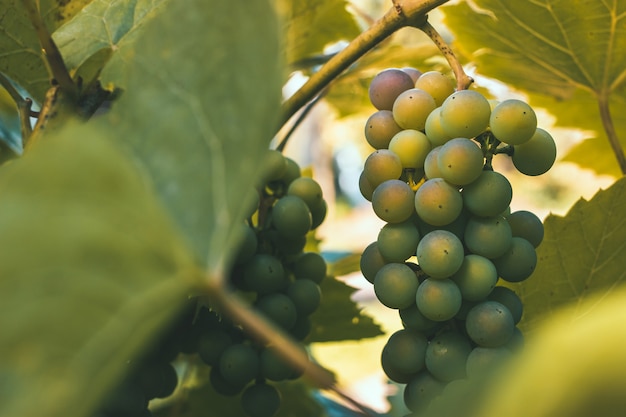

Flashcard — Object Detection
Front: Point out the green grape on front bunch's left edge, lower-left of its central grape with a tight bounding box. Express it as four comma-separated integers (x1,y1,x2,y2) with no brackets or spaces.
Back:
374,263,419,309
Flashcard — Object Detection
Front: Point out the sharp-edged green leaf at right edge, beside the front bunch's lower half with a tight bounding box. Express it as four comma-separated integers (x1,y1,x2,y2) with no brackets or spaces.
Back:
513,178,626,331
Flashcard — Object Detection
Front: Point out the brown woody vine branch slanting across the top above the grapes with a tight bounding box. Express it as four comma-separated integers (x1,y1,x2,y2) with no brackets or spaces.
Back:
279,0,449,127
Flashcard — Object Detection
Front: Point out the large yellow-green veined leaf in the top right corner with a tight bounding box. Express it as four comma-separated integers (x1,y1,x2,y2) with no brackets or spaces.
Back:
442,0,626,174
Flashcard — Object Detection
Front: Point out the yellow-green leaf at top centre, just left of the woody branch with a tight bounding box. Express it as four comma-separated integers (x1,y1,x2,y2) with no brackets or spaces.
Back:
276,0,361,65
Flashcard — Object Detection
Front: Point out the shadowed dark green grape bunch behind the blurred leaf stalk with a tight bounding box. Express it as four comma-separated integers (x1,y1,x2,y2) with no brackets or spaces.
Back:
93,150,327,417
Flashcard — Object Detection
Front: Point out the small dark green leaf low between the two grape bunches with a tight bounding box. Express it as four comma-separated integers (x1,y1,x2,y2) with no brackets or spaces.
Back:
306,276,384,343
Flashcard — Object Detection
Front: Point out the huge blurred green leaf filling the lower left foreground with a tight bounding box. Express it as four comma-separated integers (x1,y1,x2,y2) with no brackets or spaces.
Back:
0,128,199,417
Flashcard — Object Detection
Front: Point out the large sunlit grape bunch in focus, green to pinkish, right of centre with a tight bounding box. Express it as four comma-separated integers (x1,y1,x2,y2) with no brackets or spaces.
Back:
359,68,556,412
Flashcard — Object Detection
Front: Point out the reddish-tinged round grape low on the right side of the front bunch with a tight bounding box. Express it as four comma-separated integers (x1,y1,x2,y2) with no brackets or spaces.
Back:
465,301,515,347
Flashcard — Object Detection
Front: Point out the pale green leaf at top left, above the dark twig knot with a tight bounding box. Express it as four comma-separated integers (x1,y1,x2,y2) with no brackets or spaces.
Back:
53,0,167,86
